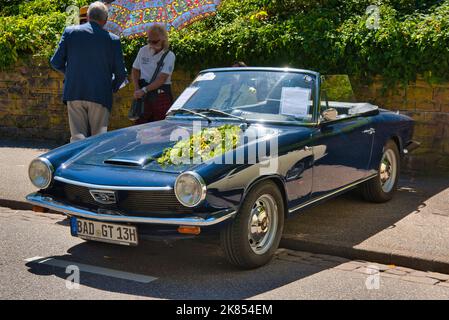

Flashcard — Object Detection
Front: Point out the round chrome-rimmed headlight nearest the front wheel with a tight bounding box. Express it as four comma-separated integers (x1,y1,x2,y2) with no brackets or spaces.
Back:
175,172,206,207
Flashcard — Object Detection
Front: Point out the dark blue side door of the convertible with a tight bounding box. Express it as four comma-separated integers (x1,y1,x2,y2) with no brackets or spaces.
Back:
311,116,375,198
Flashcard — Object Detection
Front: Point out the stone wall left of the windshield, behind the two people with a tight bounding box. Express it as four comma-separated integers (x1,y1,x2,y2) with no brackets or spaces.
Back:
0,60,194,142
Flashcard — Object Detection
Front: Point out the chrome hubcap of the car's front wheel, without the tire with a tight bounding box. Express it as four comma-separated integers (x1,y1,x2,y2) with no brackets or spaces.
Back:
248,194,278,255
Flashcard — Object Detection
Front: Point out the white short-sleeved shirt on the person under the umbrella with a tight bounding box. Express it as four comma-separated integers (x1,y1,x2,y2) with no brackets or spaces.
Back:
133,45,176,84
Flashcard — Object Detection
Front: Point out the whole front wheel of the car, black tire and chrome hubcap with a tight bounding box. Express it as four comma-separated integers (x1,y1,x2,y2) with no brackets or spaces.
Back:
221,181,284,269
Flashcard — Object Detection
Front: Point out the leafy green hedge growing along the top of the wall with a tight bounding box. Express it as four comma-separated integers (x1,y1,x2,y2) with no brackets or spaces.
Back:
0,0,449,83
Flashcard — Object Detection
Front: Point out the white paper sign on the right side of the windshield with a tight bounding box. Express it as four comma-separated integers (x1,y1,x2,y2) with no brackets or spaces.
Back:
280,87,312,117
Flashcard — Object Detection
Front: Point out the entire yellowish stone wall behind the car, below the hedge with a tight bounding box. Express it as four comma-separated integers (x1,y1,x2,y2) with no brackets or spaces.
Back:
0,61,449,172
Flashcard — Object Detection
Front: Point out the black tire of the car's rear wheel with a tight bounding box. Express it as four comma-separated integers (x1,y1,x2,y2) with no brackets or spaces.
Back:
360,140,401,203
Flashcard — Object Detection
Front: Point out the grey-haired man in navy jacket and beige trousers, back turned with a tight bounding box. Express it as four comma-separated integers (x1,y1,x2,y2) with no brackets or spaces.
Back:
50,1,126,142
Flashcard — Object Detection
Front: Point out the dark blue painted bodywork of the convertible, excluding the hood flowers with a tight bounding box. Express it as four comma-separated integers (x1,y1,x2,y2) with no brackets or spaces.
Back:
33,70,413,238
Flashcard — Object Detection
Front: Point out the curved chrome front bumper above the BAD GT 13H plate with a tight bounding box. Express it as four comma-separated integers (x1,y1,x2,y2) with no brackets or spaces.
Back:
26,192,236,227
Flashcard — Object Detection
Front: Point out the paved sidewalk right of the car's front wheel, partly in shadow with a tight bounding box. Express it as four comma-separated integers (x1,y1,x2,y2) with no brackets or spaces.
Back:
281,176,449,273
